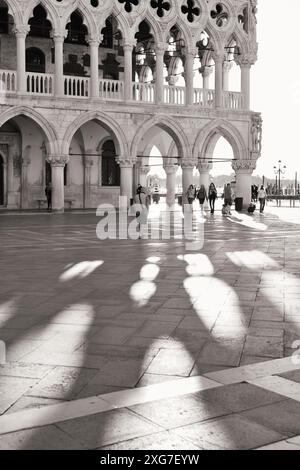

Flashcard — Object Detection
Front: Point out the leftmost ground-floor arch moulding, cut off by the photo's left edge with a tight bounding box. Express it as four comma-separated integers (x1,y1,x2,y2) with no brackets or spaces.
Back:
0,106,60,155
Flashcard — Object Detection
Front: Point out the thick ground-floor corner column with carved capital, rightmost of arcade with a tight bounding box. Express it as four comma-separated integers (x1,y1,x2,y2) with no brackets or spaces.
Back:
232,159,256,208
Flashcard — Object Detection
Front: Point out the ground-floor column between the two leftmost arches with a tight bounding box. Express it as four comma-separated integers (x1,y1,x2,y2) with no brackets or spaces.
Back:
47,155,69,212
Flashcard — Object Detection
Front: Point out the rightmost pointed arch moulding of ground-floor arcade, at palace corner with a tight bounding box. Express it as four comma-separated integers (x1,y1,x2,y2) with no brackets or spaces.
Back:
193,119,247,160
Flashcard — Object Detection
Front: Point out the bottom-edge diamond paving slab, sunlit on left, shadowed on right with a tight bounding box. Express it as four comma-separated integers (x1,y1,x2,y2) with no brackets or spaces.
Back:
176,415,285,450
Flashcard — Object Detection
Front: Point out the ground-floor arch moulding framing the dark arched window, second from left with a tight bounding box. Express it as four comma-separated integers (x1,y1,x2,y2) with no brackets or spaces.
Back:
63,111,129,157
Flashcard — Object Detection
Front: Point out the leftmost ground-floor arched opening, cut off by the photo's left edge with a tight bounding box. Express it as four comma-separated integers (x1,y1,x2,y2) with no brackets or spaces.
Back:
0,114,51,209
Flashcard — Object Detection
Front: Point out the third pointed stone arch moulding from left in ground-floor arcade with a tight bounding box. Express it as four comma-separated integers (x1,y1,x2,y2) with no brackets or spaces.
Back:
131,116,190,159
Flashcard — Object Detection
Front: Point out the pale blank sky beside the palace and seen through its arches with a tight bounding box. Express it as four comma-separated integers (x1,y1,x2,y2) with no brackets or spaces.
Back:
152,0,300,181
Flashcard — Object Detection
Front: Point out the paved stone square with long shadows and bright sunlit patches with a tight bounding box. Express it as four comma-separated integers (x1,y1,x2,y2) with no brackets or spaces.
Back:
0,207,300,449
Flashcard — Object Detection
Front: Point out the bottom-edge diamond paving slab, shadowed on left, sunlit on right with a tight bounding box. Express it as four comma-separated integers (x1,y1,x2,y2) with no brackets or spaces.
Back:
57,410,161,449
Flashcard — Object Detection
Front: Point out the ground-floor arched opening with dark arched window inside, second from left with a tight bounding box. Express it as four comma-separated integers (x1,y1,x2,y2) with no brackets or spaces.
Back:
65,119,120,208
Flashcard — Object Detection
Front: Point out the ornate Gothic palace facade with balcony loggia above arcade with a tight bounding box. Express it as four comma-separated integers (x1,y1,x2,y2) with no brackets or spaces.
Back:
0,0,262,211
